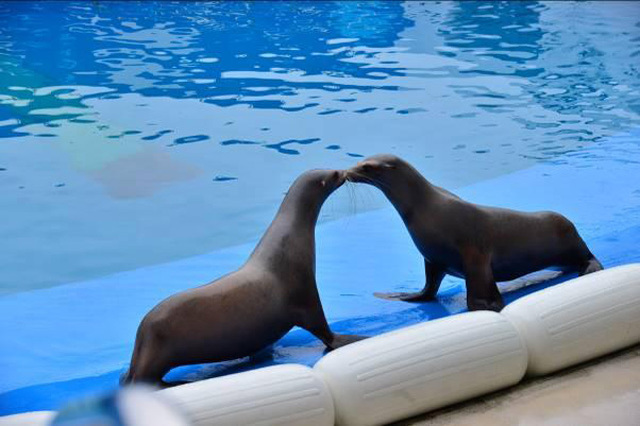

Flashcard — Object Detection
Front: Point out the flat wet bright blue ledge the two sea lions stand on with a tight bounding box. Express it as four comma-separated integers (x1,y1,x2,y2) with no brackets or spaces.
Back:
0,131,640,415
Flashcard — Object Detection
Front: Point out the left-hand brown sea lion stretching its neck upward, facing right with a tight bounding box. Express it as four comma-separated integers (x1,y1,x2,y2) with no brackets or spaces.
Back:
121,170,362,384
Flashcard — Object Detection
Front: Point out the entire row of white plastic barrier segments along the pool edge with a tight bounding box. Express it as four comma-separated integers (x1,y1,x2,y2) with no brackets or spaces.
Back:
0,264,640,426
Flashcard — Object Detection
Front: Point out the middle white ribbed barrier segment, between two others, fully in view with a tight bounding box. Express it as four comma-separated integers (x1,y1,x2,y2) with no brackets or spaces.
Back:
314,311,527,425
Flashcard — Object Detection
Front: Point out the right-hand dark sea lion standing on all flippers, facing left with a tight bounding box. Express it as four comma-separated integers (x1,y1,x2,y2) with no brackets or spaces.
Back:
346,154,603,311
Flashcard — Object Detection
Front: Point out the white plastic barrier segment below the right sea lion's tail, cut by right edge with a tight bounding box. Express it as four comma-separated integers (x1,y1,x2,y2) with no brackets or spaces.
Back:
502,264,640,375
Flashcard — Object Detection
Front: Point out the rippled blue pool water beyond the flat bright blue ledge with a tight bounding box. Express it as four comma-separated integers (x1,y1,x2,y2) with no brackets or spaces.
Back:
0,2,640,294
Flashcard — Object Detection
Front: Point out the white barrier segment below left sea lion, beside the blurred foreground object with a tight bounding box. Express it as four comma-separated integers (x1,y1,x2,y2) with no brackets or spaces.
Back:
159,364,334,426
